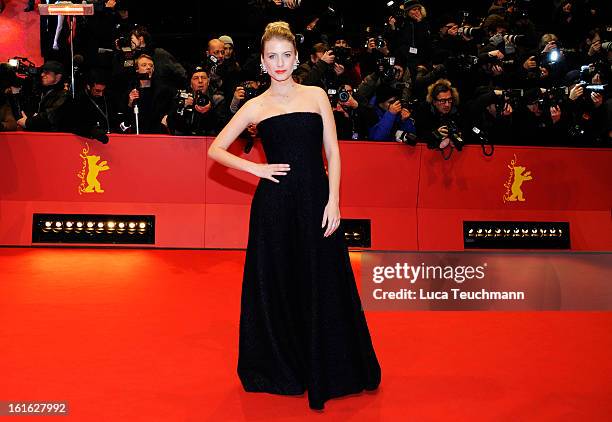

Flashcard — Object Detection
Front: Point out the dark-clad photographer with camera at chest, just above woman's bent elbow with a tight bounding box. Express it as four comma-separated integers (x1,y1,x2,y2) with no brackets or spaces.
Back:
167,66,223,136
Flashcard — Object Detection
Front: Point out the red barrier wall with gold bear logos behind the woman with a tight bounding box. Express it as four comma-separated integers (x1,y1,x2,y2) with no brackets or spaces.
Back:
0,132,612,250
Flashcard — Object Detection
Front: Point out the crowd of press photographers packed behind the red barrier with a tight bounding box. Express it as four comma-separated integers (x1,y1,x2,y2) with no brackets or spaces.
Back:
0,0,612,152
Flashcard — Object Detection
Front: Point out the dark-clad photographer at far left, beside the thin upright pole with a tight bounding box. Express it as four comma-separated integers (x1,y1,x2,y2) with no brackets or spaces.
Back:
17,60,72,132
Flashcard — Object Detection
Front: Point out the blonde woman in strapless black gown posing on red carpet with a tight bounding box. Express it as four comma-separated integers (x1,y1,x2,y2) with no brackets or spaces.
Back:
208,22,381,409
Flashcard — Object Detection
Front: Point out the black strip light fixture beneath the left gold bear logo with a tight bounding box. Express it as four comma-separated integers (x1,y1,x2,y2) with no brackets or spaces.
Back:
32,214,155,245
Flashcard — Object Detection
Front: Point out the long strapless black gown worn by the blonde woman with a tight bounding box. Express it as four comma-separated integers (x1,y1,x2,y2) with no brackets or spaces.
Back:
238,112,381,409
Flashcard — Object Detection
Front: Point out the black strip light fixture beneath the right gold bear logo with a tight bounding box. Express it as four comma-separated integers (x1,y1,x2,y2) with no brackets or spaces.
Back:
463,221,570,249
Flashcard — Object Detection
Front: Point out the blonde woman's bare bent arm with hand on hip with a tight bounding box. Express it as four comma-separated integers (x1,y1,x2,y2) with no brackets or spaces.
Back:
208,101,289,183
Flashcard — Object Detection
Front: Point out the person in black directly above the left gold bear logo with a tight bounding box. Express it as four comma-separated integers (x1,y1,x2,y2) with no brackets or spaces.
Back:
73,69,115,144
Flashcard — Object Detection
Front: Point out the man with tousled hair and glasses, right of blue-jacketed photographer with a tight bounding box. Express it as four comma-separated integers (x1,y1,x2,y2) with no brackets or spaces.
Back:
414,79,464,150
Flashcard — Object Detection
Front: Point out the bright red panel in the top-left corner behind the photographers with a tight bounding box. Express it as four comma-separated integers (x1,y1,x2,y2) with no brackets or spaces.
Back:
0,0,43,66
